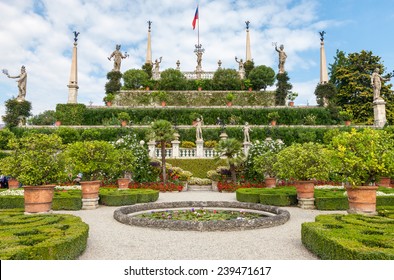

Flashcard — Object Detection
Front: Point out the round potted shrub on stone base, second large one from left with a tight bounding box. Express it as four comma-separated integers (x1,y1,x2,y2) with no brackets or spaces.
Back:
64,140,117,209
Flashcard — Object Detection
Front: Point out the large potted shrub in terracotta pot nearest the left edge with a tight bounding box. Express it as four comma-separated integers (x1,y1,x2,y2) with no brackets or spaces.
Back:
1,134,66,213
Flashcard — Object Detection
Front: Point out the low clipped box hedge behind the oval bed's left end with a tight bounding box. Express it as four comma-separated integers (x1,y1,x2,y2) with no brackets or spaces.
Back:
99,188,159,206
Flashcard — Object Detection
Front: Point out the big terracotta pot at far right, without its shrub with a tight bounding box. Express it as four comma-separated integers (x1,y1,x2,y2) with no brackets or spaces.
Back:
346,186,378,215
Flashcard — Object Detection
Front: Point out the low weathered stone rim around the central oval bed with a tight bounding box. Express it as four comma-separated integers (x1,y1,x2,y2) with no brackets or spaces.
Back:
114,201,290,231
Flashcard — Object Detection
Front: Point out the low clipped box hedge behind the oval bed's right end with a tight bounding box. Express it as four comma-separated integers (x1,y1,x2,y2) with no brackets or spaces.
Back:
236,187,297,206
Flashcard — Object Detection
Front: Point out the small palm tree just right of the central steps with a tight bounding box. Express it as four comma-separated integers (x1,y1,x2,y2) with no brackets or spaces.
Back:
216,138,245,183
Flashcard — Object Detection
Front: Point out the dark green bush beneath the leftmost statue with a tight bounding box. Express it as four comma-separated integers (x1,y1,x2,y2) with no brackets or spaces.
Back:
3,98,31,128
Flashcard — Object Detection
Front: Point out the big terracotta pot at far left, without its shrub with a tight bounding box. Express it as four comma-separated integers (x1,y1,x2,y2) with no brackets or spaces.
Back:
23,185,55,213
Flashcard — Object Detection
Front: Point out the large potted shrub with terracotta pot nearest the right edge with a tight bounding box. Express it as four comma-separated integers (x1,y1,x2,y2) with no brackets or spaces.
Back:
331,129,394,214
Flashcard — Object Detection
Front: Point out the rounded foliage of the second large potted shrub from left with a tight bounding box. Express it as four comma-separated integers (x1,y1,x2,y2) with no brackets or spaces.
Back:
64,140,117,181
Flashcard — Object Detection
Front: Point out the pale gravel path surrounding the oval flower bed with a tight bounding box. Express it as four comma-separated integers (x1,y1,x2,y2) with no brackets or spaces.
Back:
61,191,345,260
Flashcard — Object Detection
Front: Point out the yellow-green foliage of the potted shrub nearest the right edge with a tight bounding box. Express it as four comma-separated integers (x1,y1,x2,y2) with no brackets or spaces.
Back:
331,129,394,186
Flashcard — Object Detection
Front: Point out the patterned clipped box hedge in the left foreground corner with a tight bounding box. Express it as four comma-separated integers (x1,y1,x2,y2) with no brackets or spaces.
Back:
0,209,89,260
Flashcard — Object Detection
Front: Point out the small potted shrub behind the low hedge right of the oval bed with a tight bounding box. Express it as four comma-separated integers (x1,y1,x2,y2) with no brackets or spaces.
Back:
253,138,284,188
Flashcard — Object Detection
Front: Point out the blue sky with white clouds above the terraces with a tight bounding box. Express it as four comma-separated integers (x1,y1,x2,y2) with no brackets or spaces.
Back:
0,0,394,123
